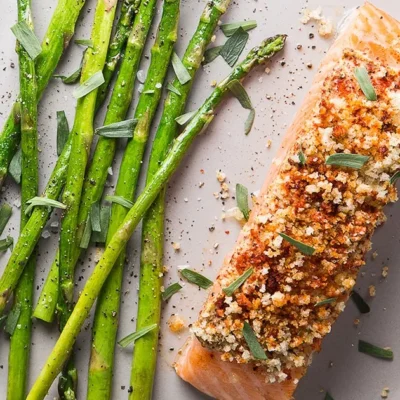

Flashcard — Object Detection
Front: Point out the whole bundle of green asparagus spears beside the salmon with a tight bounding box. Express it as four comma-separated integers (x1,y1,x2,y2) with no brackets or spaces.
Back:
0,0,286,400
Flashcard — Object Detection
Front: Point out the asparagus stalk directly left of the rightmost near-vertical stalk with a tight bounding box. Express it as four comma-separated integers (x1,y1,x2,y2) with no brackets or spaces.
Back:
87,0,180,400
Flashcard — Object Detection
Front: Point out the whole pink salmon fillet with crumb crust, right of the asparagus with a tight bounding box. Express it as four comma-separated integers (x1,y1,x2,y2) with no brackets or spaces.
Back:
175,3,400,400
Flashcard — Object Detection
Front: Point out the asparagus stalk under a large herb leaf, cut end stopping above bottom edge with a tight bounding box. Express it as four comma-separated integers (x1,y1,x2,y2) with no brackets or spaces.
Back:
34,0,156,322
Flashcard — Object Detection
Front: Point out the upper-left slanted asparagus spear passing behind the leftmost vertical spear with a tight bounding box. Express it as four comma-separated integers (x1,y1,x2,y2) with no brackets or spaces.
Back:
0,0,86,187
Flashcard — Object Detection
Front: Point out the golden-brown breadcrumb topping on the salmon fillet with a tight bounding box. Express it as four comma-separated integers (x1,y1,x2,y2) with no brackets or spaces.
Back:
193,50,400,382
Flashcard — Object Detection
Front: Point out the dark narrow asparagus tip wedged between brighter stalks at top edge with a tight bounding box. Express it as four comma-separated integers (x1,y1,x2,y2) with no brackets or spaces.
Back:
96,0,141,109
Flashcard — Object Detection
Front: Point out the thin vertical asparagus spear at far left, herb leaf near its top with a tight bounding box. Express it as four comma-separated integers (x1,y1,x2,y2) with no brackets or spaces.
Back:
7,0,39,400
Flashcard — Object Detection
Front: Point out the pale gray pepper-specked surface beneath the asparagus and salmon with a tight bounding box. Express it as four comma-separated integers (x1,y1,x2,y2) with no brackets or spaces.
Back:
0,0,400,400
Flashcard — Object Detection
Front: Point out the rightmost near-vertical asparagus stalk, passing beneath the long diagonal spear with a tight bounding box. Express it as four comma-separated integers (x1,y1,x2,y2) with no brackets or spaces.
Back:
131,0,230,400
